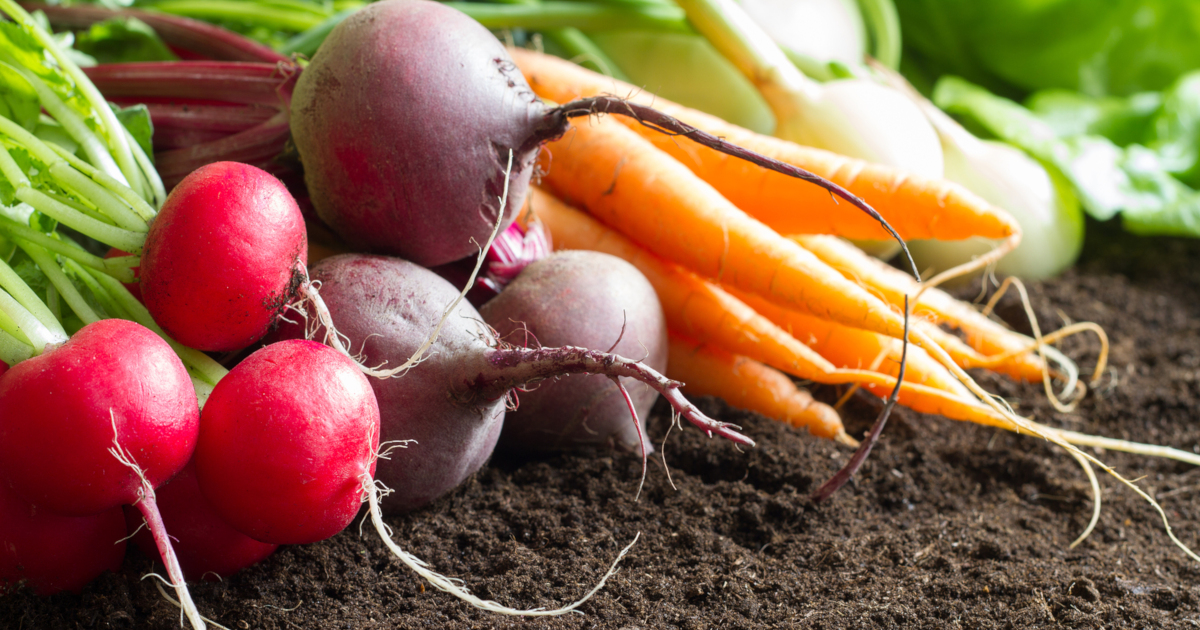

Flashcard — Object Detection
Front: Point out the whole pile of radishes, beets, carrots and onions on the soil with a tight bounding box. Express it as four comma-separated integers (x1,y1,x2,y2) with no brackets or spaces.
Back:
7,0,1200,628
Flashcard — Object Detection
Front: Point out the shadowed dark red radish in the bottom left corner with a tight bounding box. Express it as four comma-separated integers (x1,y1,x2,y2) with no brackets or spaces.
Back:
0,484,125,595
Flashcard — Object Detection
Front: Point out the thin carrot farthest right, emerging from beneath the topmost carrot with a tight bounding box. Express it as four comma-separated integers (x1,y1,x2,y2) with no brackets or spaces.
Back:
792,235,1045,382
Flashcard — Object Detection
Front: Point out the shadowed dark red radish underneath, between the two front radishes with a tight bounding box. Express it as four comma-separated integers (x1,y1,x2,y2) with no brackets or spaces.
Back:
125,463,278,580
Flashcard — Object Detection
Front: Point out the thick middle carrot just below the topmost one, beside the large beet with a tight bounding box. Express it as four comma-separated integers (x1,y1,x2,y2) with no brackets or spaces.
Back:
541,118,904,337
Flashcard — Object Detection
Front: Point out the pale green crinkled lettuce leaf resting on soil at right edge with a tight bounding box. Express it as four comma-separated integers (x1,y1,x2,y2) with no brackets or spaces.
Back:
934,73,1200,236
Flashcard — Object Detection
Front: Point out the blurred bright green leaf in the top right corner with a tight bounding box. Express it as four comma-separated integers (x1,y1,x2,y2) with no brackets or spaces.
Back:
895,0,1200,96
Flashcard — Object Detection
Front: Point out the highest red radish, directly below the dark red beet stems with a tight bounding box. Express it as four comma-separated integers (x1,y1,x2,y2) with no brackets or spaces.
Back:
140,162,307,352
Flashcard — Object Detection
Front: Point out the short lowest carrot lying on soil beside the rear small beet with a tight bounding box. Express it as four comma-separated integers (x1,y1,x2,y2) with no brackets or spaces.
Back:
667,332,858,446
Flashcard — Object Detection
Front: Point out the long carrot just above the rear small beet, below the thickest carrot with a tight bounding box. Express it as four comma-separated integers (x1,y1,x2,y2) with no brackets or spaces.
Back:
529,187,1013,430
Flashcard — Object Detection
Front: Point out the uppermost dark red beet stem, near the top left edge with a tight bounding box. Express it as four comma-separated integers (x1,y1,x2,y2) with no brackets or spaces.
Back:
20,2,290,64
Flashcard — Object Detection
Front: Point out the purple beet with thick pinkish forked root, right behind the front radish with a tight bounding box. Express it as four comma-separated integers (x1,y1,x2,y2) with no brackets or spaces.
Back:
272,254,752,514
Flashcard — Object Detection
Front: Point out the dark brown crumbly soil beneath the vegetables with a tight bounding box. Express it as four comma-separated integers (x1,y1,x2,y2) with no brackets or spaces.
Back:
7,217,1200,630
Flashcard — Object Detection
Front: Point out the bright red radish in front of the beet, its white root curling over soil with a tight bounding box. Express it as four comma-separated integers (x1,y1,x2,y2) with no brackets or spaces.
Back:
196,340,379,545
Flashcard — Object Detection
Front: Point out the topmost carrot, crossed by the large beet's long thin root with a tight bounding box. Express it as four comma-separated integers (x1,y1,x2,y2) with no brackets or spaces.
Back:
509,49,1020,246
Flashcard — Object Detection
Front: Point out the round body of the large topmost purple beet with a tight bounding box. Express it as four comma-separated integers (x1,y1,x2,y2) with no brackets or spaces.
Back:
292,0,546,266
